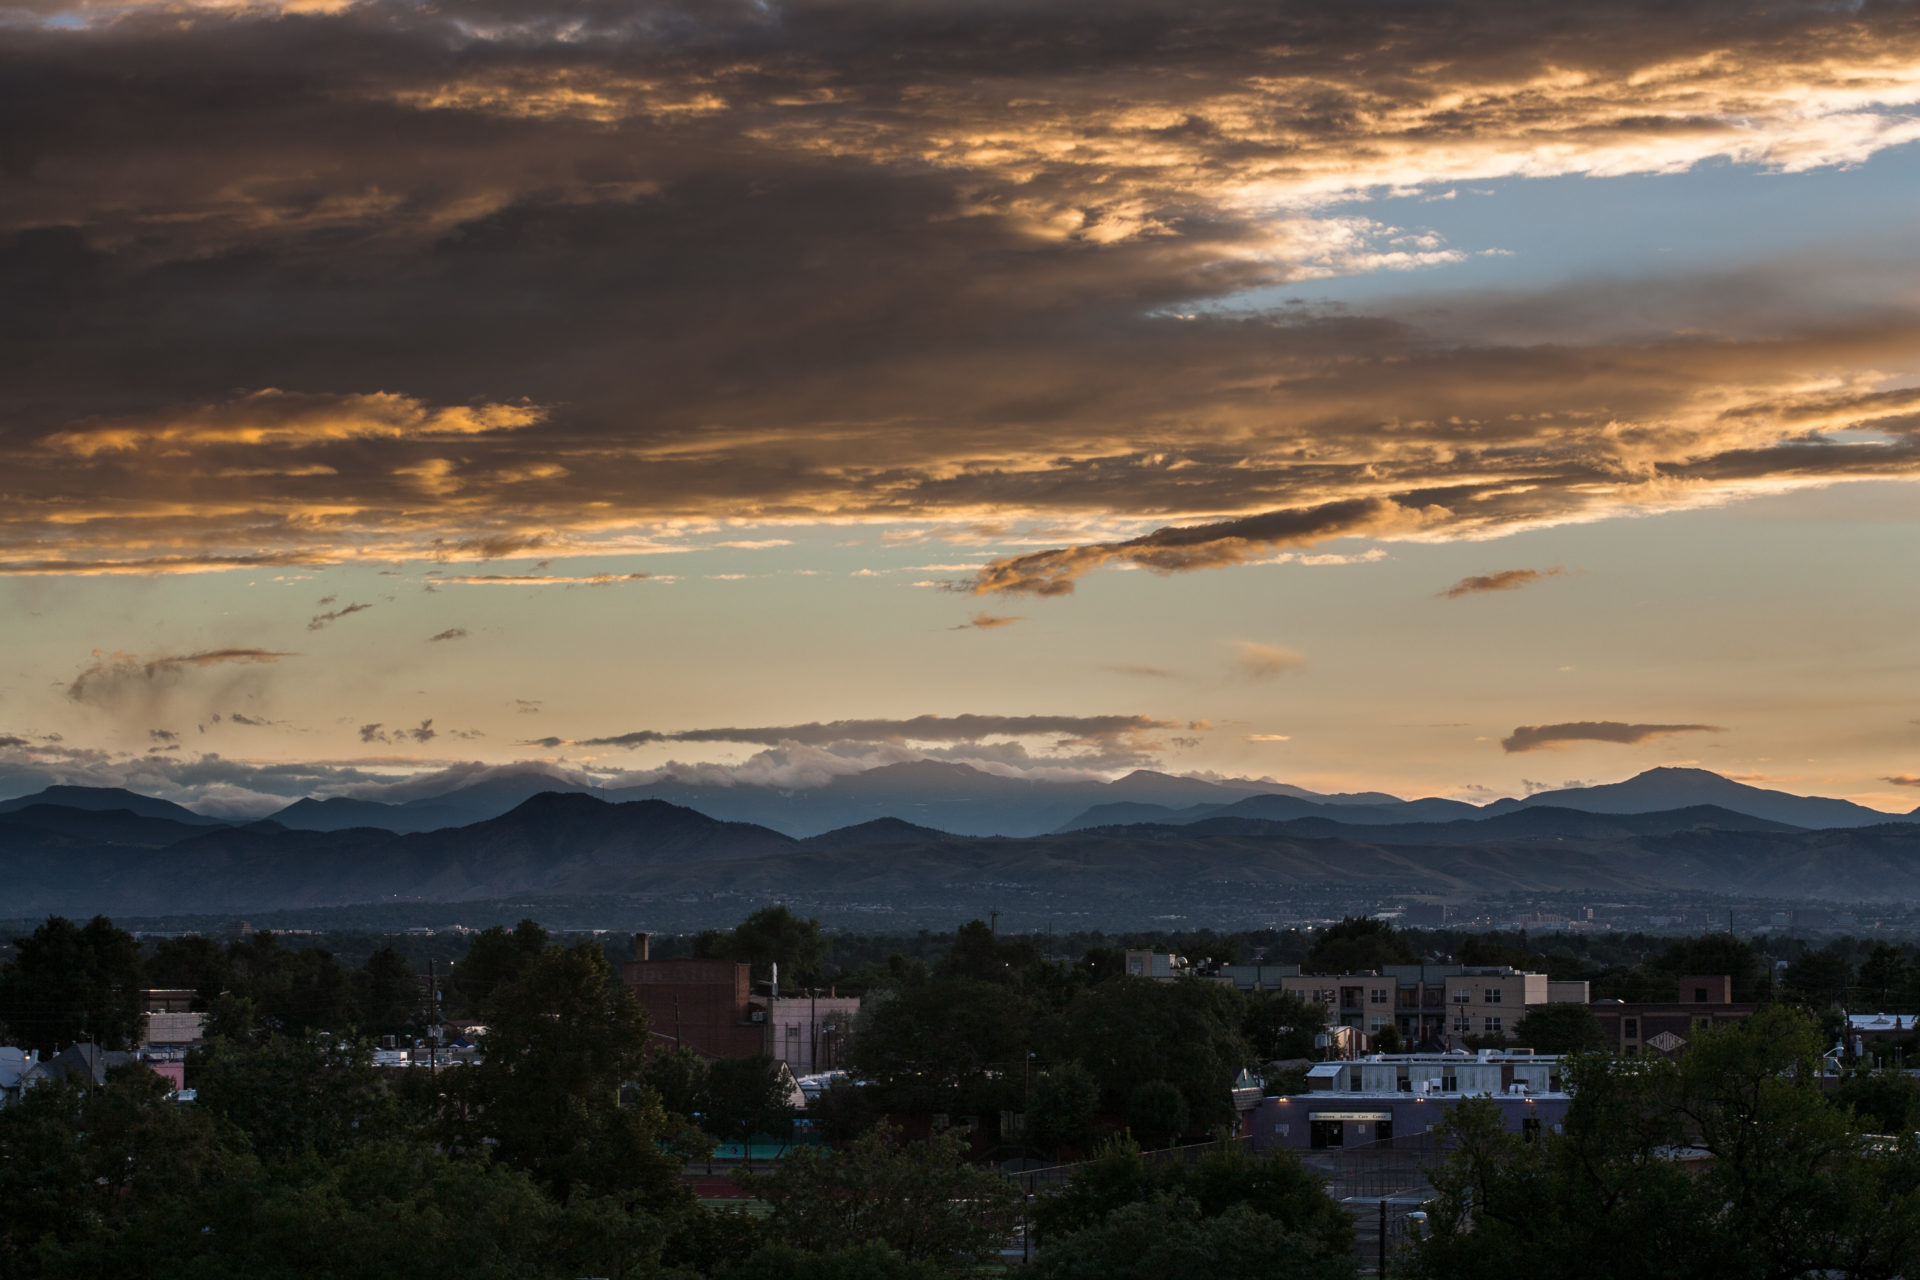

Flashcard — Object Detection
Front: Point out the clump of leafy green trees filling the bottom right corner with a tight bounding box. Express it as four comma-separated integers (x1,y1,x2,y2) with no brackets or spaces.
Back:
1402,1006,1920,1280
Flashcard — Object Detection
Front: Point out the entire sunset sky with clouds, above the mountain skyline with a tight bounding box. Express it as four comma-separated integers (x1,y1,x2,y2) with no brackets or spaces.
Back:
0,0,1920,812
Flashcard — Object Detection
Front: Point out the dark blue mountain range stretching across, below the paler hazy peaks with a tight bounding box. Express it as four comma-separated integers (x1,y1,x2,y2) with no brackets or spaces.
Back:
0,770,1920,923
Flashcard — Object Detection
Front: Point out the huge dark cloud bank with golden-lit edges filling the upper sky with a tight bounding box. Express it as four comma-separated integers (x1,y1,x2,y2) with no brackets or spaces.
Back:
0,0,1920,579
